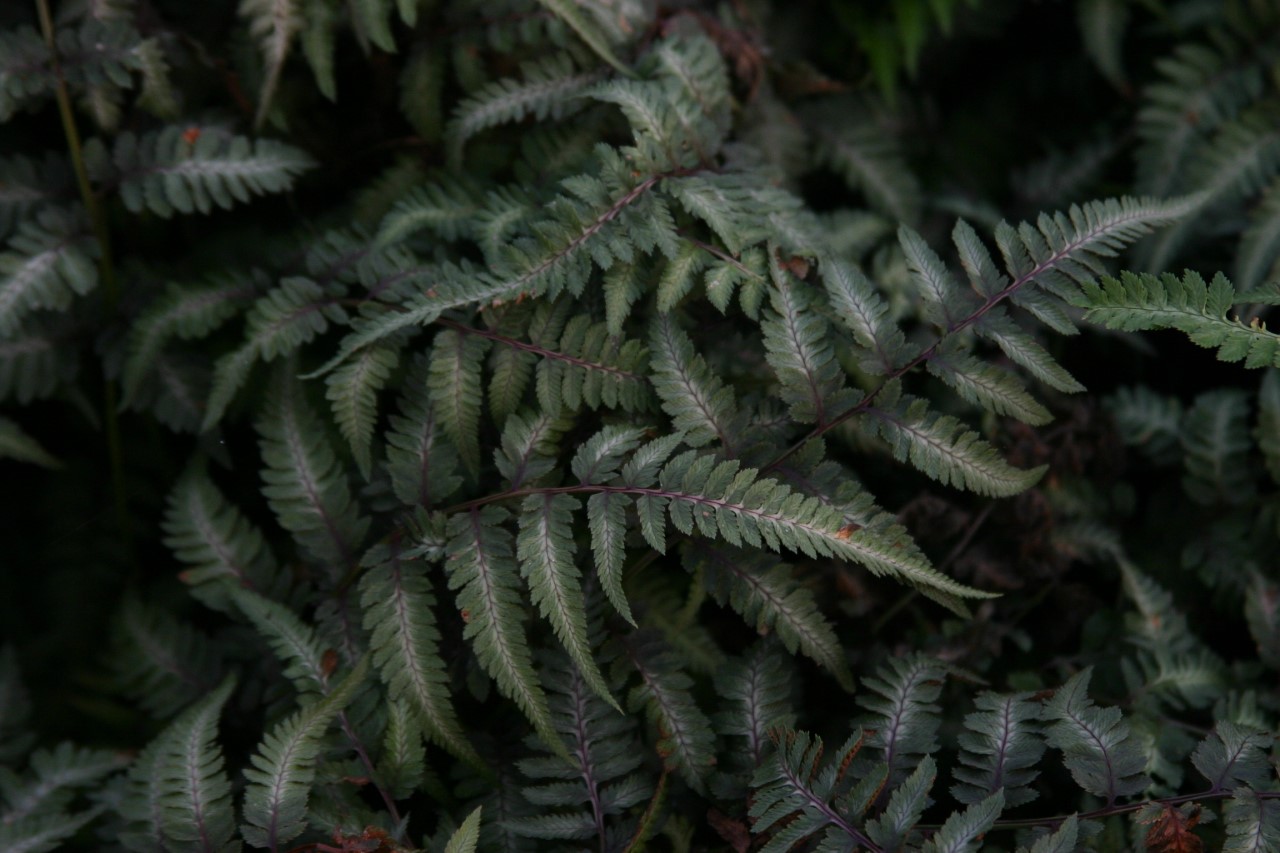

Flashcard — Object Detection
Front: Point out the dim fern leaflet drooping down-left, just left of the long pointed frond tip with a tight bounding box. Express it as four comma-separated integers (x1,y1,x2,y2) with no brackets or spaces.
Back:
201,278,347,430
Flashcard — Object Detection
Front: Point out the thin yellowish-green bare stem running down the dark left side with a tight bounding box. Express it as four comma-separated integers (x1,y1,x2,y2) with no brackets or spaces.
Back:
36,0,132,551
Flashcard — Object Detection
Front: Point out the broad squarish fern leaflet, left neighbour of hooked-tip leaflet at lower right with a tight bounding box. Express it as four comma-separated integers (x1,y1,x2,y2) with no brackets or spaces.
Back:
951,690,1044,806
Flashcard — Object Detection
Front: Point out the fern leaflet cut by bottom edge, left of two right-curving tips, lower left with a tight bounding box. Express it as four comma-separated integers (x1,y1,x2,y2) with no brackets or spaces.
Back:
122,678,236,853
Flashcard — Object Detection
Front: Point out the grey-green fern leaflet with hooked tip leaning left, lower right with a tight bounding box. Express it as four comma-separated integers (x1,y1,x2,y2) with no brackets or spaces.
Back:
1042,669,1151,806
